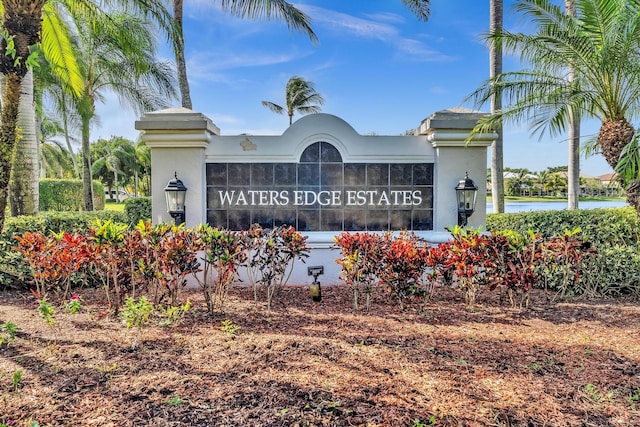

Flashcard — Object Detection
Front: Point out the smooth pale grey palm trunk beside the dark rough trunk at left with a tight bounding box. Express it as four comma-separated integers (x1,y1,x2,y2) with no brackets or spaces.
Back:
9,70,39,216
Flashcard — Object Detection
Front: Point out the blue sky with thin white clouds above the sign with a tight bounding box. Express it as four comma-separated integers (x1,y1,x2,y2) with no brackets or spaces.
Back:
92,0,611,175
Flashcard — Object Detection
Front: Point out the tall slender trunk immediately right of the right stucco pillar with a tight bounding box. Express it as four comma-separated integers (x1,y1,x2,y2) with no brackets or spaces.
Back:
489,0,504,213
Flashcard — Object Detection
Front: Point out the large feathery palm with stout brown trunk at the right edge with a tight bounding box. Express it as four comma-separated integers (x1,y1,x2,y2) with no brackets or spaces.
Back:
470,0,640,213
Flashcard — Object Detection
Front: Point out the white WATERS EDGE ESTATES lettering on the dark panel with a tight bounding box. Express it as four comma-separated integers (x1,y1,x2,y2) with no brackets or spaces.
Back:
218,190,422,206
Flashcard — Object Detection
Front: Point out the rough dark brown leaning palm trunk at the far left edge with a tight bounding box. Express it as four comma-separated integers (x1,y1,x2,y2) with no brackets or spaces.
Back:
0,73,22,230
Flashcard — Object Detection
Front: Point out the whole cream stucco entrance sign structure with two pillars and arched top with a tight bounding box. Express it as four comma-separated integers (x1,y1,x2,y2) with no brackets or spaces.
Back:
136,108,495,280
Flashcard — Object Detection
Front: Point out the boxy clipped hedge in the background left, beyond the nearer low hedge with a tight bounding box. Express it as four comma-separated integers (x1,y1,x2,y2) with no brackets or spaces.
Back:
39,179,105,212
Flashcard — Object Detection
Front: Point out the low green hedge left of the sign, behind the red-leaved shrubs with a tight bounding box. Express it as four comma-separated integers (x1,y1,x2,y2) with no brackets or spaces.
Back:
0,211,127,289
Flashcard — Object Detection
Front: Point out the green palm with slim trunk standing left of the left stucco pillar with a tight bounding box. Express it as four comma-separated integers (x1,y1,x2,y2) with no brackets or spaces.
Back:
74,14,176,211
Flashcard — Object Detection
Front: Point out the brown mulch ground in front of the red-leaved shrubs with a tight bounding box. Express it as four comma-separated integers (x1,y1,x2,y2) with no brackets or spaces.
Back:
0,287,640,427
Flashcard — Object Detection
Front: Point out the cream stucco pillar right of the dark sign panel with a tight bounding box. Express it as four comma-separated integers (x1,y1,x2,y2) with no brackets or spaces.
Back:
420,109,497,232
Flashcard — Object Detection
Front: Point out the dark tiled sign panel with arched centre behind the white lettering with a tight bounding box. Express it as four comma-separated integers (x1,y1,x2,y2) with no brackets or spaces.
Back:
207,142,433,231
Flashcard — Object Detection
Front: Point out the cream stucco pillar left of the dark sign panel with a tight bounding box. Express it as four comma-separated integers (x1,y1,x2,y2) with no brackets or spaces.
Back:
135,107,220,228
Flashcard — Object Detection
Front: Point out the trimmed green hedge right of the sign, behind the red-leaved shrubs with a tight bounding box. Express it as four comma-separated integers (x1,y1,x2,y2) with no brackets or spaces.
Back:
487,207,640,247
